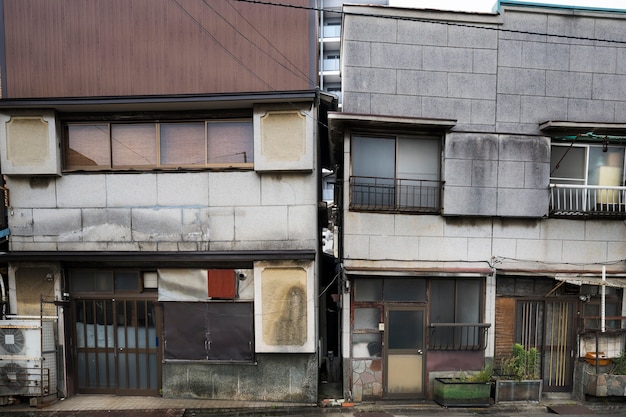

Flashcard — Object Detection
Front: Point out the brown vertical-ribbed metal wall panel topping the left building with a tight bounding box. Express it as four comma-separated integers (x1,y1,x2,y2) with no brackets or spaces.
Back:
3,0,317,98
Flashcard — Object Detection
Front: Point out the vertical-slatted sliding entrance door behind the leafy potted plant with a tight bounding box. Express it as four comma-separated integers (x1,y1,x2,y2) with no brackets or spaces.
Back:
516,300,576,392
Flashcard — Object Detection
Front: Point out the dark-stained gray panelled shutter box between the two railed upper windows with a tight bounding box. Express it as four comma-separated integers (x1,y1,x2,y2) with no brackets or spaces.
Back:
443,133,550,217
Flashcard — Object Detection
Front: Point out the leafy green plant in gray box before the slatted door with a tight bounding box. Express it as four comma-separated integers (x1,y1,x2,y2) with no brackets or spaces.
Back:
494,343,543,403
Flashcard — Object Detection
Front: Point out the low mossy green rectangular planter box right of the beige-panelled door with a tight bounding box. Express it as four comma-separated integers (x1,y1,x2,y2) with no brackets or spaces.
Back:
433,378,491,407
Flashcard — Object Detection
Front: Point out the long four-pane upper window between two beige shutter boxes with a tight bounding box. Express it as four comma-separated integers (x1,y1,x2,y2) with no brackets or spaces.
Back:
64,119,254,170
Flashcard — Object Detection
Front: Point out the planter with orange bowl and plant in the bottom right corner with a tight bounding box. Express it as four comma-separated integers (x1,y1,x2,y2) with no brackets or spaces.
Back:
583,350,626,397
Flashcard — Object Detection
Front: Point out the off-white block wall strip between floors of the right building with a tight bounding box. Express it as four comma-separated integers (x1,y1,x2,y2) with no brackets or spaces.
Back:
344,212,626,270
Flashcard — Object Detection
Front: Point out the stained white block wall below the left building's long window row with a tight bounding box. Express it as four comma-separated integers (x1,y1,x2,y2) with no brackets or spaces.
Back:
7,171,318,251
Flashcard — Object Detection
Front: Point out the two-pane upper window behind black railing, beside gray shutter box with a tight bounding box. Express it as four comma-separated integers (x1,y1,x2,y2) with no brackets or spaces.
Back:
350,135,441,213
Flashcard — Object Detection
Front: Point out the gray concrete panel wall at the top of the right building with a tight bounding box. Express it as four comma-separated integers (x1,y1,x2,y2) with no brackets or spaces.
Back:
342,7,626,135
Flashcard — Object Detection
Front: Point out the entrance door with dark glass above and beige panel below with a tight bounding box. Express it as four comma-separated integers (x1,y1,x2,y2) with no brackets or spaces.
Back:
385,307,424,397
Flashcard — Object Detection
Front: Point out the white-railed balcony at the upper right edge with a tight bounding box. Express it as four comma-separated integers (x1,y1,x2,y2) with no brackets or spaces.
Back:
550,184,626,218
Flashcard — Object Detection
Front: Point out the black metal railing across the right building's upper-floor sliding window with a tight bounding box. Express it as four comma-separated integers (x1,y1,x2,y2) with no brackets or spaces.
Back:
350,176,443,213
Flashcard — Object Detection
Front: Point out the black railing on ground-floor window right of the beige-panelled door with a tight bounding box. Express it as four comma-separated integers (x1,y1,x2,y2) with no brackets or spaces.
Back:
428,323,491,350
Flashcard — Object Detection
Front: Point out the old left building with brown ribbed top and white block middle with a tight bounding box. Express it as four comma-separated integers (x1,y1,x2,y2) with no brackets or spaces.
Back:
0,0,337,402
